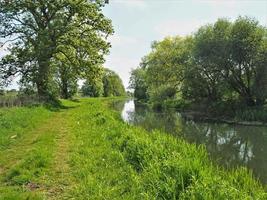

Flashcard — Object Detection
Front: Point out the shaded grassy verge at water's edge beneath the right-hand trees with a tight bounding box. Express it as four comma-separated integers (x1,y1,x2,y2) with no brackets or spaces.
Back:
149,99,267,125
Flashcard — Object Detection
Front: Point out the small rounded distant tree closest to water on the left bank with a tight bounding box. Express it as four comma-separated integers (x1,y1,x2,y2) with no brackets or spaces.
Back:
102,69,126,97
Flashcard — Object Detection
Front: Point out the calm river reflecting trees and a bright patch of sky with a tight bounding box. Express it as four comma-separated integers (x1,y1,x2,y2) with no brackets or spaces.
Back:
113,100,267,184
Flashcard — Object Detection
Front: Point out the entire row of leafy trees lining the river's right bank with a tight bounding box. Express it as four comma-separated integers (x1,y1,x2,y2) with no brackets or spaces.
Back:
130,17,267,111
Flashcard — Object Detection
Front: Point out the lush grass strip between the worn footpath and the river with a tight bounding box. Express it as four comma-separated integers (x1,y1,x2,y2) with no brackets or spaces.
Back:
63,100,267,199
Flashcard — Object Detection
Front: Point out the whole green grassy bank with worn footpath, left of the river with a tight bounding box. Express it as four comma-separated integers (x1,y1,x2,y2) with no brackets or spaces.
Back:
0,98,267,200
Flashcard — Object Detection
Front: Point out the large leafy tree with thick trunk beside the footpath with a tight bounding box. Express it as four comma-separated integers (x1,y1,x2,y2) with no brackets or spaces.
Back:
0,0,113,97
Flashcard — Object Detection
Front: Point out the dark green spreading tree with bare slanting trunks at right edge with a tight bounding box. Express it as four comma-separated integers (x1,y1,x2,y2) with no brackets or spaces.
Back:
193,17,267,106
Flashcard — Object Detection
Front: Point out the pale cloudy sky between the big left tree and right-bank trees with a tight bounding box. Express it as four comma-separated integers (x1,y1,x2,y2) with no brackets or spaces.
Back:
103,0,267,88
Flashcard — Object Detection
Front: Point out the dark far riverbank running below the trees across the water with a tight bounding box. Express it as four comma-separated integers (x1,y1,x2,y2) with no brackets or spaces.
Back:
143,100,267,126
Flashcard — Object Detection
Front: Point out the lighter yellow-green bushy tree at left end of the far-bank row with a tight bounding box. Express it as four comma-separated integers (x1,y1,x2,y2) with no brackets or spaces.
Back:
130,36,193,102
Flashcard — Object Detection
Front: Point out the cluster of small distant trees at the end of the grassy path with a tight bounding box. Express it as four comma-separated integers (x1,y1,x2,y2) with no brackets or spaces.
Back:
81,69,126,97
